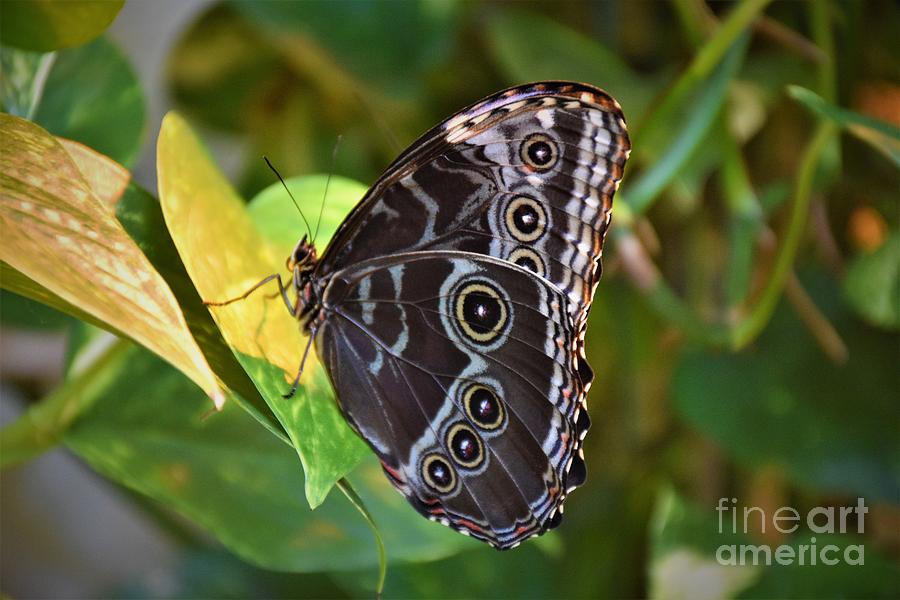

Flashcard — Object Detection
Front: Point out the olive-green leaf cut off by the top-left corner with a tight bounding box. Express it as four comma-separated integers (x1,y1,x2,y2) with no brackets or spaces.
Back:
0,0,125,52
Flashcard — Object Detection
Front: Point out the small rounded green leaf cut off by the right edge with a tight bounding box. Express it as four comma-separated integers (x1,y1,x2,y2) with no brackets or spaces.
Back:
843,231,900,330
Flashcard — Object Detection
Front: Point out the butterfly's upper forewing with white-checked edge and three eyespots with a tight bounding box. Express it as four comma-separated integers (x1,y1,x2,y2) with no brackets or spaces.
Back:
321,82,630,334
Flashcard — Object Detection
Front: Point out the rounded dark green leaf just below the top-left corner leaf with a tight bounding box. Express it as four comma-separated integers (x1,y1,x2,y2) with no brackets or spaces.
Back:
31,37,145,166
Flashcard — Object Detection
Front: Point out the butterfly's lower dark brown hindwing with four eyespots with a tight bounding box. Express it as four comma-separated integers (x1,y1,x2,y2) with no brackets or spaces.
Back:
316,251,587,548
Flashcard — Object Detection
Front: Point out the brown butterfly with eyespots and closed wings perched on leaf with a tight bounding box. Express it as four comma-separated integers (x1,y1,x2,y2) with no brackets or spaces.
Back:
214,81,630,549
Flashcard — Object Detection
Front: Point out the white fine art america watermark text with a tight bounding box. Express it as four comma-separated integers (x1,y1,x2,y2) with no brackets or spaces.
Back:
716,498,869,566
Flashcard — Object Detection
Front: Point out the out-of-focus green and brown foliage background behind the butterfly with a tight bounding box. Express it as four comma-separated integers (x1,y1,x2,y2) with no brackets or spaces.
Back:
0,0,900,598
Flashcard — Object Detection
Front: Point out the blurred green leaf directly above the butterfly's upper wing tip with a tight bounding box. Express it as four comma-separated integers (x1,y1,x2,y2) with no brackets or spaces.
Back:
487,10,660,124
